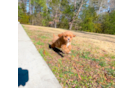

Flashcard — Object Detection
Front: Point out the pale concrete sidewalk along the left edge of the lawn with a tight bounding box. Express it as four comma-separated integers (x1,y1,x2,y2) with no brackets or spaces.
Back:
18,22,62,88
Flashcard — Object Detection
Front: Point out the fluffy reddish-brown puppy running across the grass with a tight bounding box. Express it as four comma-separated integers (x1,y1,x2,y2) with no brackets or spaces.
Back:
51,31,76,54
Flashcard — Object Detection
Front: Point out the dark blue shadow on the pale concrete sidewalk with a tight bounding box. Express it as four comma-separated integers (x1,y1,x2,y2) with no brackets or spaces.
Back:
18,68,29,87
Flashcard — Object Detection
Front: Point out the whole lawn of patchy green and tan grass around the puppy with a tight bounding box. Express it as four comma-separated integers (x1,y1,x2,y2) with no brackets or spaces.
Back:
23,25,115,88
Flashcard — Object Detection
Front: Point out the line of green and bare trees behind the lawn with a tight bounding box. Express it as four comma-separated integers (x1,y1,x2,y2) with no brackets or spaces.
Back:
18,0,115,34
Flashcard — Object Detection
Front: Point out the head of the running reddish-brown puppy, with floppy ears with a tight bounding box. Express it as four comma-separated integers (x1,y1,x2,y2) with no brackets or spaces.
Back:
58,31,76,42
